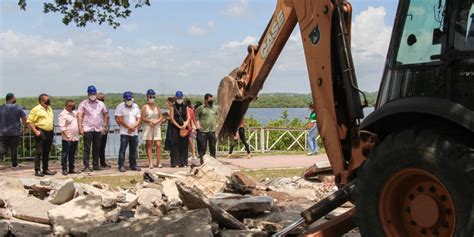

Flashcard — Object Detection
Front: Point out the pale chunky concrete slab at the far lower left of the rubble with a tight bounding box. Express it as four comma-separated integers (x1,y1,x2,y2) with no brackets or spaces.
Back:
9,197,57,224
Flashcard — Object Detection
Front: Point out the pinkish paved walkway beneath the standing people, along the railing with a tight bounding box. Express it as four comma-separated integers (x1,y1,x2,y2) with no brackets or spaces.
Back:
0,155,327,178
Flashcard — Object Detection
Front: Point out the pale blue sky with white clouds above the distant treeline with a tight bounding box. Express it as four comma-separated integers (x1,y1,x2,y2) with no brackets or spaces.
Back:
0,0,397,96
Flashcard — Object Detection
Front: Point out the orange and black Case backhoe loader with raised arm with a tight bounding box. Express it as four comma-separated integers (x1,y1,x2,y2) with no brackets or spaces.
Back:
218,0,474,237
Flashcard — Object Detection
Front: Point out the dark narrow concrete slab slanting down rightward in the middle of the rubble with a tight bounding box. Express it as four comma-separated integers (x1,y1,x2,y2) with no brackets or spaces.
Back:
176,179,247,230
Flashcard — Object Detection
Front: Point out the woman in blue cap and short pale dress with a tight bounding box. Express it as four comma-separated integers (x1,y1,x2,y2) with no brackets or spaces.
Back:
141,89,163,169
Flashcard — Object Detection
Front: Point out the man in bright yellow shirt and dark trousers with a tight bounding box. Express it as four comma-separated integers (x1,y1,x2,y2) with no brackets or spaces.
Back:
26,94,56,177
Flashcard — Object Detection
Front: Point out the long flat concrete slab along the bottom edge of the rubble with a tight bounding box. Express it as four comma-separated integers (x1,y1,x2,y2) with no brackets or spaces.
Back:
88,209,212,237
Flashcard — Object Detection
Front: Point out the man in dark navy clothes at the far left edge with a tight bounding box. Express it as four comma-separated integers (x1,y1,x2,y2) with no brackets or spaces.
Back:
0,93,26,167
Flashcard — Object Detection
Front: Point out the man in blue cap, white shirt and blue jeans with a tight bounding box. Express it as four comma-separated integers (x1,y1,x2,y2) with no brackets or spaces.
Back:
115,91,140,172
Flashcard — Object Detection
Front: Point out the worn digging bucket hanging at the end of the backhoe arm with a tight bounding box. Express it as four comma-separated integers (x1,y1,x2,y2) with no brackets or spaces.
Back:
217,73,250,141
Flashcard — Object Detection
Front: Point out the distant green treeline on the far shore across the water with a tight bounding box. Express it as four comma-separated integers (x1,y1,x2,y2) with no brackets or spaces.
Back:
17,92,377,109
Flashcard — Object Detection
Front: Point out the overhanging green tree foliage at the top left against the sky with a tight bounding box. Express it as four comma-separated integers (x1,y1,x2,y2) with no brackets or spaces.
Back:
18,0,150,29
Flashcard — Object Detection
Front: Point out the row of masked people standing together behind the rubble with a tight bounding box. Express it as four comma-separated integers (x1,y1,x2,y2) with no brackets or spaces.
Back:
0,86,254,177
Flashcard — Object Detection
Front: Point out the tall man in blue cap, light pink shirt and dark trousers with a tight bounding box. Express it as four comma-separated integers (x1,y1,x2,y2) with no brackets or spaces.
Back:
77,86,108,172
